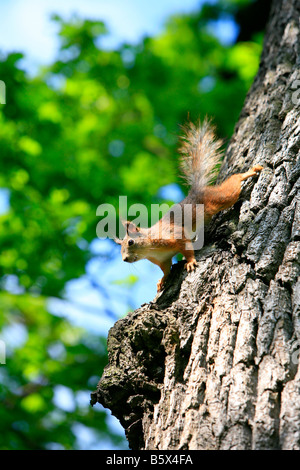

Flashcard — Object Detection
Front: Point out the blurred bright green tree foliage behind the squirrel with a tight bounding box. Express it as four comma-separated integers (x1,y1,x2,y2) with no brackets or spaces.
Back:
0,0,269,449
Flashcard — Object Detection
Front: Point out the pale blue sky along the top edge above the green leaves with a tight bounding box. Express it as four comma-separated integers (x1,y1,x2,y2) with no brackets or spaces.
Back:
0,0,203,71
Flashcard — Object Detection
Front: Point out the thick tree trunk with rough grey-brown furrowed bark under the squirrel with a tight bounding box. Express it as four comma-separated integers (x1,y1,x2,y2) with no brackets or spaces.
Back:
92,0,300,450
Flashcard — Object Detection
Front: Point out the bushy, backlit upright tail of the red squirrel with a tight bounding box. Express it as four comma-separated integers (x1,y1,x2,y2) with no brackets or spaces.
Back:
180,118,222,191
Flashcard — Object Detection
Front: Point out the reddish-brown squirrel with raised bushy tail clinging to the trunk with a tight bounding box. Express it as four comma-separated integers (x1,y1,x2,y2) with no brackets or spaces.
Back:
115,118,263,292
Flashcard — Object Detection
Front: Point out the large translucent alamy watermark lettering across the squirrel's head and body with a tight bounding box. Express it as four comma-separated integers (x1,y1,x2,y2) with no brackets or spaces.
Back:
96,196,204,250
